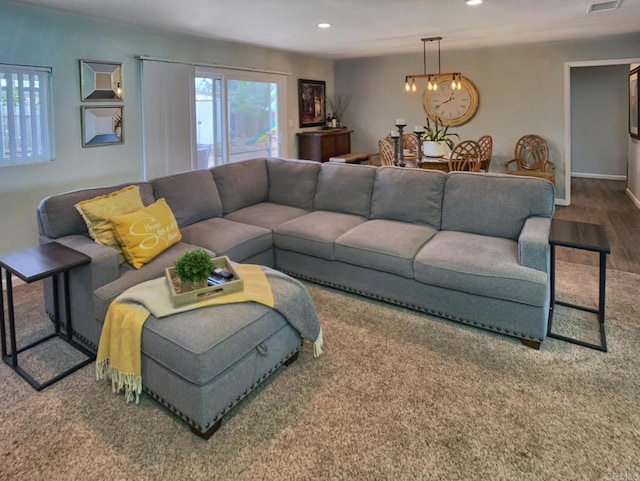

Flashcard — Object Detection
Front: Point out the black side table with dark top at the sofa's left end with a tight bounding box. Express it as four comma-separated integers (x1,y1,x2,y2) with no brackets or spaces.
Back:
0,242,95,391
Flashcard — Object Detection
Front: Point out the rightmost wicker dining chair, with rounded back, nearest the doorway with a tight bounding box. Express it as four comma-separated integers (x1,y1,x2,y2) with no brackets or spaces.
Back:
504,134,556,184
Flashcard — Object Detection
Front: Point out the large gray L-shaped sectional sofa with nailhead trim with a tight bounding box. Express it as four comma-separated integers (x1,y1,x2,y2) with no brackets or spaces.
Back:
37,158,554,348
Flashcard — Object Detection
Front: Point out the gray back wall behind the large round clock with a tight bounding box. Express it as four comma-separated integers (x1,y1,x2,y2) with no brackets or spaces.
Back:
335,34,640,199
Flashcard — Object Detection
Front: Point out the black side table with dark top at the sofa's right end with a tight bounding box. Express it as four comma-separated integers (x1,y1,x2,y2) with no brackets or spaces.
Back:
547,219,611,352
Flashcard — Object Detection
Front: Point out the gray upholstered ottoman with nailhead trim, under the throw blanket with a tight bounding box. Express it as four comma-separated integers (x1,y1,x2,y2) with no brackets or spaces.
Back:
142,300,306,439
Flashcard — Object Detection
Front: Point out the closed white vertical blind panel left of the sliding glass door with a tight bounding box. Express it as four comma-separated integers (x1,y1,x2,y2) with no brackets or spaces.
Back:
141,59,195,179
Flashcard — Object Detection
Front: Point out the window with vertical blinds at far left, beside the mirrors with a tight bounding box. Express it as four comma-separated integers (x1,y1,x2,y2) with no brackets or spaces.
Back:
0,64,55,166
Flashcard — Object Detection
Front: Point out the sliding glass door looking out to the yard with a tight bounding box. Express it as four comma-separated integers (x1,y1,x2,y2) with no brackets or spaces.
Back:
195,67,286,168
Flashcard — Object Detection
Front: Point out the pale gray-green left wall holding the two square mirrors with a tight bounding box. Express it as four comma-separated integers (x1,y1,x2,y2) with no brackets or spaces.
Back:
0,0,334,254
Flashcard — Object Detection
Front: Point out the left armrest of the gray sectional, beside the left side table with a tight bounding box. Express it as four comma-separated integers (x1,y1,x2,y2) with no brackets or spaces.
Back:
48,235,120,291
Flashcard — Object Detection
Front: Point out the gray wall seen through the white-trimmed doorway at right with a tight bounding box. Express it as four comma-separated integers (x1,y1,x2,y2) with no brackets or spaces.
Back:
571,65,629,179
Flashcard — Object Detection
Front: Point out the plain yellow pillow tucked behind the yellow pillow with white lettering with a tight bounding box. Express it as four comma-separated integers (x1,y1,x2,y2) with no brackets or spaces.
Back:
75,185,144,264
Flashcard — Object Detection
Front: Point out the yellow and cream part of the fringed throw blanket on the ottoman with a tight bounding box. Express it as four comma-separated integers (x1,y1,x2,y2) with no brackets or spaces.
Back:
96,263,282,403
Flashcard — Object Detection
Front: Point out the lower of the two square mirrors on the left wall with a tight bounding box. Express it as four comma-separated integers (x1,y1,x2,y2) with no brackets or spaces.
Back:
81,106,124,147
